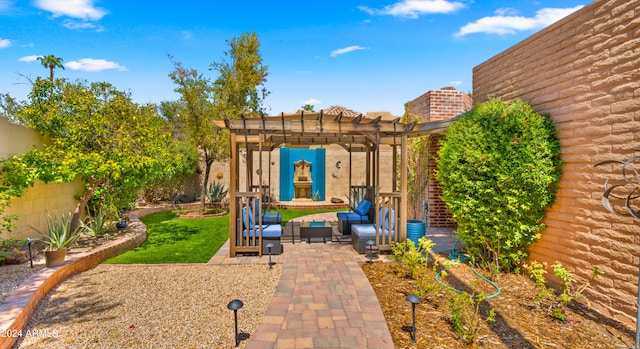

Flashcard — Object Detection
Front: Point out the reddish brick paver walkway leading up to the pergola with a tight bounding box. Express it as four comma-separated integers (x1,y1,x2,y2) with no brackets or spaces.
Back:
209,209,454,349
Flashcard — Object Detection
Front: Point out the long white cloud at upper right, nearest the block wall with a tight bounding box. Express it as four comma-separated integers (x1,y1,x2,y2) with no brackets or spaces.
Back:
454,5,583,37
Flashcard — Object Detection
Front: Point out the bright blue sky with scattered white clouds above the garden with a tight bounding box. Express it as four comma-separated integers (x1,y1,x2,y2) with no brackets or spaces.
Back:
0,0,590,115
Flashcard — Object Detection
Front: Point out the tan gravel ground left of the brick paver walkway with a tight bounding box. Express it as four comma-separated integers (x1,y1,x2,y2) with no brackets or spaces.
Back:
15,264,282,348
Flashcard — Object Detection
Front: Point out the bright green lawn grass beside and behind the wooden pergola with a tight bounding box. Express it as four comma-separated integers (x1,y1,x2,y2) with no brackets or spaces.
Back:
103,209,344,264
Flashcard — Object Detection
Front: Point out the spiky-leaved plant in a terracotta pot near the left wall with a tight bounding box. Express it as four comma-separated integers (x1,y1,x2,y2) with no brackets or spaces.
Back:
40,213,80,268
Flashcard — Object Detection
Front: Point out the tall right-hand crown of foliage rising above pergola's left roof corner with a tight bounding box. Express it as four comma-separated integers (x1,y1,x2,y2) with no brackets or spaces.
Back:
210,32,269,119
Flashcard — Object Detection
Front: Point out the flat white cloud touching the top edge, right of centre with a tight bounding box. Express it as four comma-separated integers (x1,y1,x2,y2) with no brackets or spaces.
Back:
358,0,465,19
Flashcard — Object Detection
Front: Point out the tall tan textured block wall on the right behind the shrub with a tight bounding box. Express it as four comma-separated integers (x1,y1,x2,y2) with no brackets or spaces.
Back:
473,0,640,325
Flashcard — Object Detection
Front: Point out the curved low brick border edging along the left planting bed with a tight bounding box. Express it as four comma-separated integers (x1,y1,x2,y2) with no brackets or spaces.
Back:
0,204,189,349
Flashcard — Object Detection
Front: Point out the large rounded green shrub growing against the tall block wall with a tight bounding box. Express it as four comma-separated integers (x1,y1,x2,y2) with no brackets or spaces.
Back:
436,100,562,273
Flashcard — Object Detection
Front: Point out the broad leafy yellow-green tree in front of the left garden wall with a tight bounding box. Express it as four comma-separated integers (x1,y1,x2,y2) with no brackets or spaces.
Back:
2,79,194,227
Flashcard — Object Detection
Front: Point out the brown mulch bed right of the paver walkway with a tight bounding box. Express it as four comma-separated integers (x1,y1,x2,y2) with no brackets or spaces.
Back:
362,261,635,349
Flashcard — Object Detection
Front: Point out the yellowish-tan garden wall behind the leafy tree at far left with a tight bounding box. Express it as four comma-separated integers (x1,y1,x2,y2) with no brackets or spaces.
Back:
0,117,84,239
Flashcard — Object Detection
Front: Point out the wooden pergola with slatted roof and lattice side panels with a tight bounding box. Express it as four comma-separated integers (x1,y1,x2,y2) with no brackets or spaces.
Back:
214,111,453,257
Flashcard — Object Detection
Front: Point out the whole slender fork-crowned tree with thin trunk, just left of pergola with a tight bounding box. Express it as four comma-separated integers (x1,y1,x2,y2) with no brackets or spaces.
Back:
165,33,268,212
